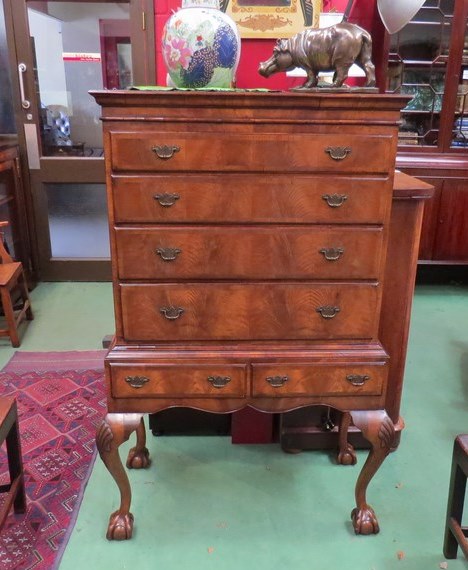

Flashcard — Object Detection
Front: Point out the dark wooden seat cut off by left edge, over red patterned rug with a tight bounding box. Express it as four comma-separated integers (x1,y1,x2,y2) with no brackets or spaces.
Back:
0,397,26,530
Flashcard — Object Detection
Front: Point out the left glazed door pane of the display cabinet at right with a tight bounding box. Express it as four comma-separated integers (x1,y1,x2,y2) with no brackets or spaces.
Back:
387,0,455,147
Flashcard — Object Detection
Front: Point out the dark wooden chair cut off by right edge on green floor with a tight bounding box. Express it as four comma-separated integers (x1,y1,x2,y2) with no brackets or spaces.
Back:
444,435,468,559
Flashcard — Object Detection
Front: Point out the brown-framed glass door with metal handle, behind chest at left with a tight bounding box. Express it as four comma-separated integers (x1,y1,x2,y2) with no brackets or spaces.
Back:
3,0,155,281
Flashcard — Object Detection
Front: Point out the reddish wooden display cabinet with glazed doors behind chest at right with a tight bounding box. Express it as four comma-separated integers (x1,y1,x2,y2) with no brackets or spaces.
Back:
386,0,468,264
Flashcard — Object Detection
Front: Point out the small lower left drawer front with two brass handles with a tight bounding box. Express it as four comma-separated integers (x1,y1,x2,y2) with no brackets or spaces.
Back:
110,363,247,398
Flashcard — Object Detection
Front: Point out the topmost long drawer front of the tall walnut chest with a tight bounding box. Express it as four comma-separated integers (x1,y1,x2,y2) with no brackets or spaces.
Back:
111,132,395,173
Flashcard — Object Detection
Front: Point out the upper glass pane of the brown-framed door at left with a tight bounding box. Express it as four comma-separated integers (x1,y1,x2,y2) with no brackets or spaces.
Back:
27,1,132,158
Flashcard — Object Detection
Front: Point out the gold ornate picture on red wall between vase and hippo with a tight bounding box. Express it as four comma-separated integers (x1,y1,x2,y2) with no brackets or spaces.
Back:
221,0,323,38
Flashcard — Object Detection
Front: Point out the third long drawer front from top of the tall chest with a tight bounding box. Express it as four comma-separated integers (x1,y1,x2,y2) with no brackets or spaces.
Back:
116,226,383,280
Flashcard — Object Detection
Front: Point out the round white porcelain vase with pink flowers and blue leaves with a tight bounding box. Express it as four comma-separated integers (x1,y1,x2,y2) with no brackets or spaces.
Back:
162,0,240,89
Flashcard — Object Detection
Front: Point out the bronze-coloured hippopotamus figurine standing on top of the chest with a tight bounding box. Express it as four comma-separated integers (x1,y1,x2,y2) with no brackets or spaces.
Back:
258,22,375,89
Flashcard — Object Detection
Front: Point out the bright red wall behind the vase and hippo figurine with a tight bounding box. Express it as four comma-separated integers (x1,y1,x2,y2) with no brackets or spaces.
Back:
154,0,383,89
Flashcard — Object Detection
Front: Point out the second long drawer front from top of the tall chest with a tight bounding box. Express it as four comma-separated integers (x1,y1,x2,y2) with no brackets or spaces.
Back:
112,174,392,224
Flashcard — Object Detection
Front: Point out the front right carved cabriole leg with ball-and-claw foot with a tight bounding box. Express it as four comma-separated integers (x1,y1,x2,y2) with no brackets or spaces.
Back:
351,410,395,534
